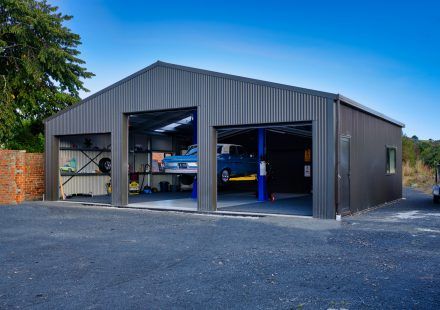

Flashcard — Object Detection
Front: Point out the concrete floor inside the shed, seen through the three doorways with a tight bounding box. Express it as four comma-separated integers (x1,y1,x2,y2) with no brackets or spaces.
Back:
68,191,313,216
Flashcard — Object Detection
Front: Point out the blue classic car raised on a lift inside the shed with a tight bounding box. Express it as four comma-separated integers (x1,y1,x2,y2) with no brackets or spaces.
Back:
163,144,258,183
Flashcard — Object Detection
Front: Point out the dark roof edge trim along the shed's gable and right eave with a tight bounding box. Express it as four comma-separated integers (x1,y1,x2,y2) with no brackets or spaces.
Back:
44,61,405,127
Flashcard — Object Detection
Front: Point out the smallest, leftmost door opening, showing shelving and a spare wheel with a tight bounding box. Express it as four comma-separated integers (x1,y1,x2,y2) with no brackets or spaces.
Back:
58,134,111,204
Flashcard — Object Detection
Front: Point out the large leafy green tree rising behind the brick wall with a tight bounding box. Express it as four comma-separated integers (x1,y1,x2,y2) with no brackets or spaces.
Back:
0,0,94,151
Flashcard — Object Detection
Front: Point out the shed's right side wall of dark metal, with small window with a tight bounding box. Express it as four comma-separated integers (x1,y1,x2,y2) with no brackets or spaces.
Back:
339,104,402,212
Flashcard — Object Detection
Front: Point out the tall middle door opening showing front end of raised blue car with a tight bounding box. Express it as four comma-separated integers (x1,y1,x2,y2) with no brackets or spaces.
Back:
128,109,198,210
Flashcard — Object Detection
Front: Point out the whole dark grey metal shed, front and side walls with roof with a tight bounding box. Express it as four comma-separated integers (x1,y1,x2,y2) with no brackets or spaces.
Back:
45,61,404,219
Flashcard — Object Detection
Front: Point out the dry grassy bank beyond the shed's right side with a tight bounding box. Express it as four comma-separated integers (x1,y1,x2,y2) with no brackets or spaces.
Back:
402,160,435,194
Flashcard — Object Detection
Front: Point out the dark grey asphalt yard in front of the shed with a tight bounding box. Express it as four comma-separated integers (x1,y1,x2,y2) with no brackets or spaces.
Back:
0,190,440,309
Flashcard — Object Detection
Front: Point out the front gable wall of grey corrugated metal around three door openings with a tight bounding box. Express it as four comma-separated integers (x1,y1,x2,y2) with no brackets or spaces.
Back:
46,64,335,218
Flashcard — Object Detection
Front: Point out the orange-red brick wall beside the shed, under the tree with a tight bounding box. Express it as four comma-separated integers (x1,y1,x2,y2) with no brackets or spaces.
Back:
0,150,44,204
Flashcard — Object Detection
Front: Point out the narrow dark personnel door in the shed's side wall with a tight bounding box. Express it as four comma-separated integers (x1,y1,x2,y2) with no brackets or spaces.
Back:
339,137,350,214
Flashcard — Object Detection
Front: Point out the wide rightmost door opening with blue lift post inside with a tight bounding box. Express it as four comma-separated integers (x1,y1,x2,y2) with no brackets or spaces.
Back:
217,123,313,216
